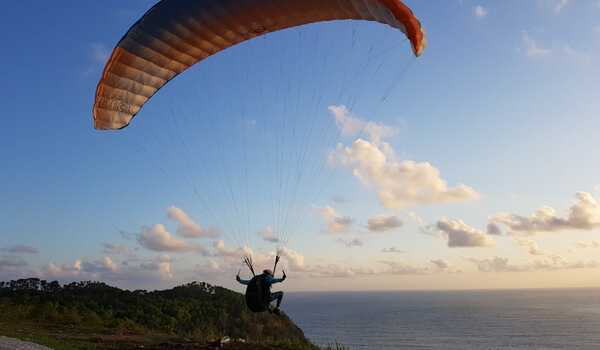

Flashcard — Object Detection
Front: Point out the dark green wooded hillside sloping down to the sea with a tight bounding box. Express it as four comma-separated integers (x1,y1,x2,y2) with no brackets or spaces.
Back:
0,279,340,350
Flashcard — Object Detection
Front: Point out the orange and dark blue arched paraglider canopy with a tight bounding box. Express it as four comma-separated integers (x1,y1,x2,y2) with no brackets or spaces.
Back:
93,0,426,130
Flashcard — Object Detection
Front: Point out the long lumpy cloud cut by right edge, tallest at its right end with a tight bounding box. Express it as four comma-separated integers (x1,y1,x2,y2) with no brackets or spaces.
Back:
490,192,600,234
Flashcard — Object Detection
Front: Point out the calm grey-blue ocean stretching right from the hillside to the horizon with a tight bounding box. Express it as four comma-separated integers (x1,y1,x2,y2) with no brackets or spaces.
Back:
284,289,600,350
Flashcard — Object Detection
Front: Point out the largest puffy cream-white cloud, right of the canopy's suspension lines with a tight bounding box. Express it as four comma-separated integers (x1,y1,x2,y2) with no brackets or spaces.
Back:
331,139,478,209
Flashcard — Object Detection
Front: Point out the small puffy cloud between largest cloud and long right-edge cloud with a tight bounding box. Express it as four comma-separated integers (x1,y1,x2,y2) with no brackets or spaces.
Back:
435,219,495,248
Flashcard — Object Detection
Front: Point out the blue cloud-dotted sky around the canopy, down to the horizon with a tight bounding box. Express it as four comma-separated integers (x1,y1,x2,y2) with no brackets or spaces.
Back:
0,0,600,291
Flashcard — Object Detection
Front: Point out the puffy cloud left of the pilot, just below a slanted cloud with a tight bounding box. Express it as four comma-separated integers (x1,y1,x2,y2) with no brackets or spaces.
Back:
138,224,206,254
